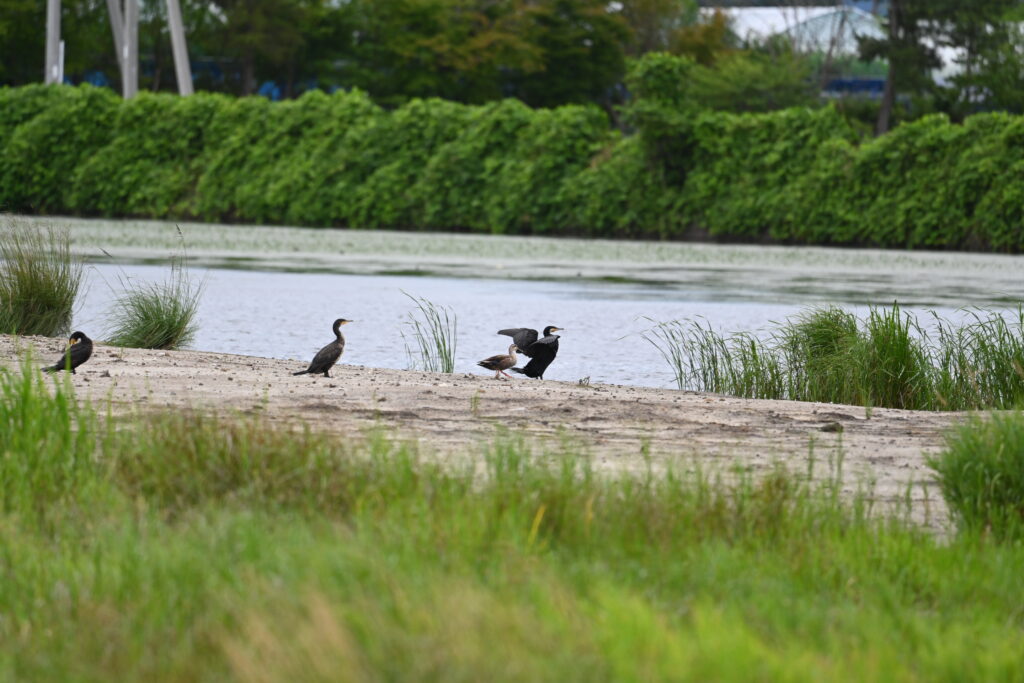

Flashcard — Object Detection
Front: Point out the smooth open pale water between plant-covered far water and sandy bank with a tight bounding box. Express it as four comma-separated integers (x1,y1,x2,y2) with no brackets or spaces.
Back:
75,263,999,387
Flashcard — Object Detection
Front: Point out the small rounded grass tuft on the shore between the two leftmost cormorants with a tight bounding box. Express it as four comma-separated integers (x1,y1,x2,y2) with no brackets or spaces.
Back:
108,258,203,349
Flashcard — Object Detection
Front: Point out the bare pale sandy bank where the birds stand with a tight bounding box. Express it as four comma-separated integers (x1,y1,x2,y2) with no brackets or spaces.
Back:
0,335,964,527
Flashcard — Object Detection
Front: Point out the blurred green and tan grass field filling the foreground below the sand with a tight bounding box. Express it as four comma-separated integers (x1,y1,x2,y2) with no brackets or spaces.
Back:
0,368,1024,681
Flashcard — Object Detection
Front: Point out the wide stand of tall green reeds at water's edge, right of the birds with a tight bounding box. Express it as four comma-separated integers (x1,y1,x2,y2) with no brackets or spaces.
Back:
643,304,1024,411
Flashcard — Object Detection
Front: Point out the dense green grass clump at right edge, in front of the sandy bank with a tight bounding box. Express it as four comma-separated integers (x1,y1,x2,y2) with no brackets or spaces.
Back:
928,412,1024,540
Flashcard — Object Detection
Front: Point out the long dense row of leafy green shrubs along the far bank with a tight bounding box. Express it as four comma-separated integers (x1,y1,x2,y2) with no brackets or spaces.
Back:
6,55,1024,252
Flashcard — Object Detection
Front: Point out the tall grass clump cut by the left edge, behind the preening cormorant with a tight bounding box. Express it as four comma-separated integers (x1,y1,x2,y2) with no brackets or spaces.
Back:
0,219,83,337
